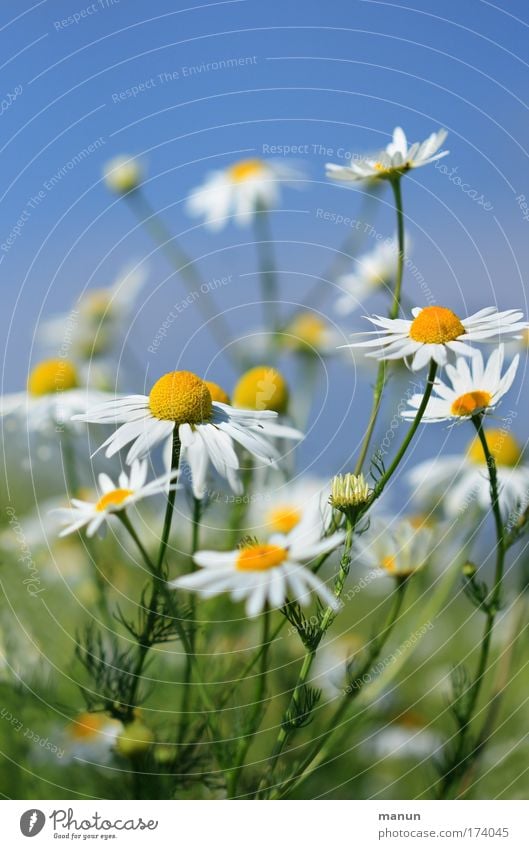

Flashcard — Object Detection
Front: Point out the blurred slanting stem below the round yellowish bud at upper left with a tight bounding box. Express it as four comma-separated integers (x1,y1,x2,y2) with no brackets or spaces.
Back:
125,188,237,365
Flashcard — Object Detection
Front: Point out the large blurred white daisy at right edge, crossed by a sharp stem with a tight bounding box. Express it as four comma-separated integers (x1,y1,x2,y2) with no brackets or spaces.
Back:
408,429,529,517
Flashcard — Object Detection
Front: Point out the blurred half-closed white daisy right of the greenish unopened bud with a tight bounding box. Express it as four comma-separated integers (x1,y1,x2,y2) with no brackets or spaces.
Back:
353,516,434,578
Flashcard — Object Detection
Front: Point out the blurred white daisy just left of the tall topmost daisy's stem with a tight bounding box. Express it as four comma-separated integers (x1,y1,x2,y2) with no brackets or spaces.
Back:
335,239,400,315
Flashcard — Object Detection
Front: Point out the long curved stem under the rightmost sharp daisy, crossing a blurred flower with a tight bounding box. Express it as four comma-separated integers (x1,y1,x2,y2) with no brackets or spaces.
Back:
439,415,506,799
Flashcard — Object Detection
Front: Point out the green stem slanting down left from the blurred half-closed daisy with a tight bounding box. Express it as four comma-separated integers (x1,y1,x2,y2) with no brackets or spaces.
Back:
274,579,408,798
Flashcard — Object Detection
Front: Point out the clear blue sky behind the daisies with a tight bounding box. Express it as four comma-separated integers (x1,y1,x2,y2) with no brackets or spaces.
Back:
0,0,529,484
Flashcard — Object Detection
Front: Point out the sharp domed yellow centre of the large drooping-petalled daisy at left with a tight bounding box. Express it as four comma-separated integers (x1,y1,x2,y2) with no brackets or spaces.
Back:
149,371,213,424
